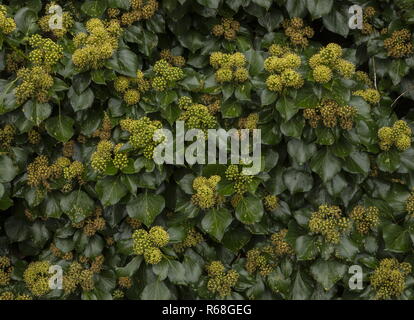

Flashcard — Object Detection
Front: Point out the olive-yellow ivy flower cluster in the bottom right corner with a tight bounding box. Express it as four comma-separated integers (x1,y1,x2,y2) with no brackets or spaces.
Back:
370,258,411,299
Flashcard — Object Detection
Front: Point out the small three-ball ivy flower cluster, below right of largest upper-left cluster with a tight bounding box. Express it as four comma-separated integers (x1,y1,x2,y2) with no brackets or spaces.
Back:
114,70,150,106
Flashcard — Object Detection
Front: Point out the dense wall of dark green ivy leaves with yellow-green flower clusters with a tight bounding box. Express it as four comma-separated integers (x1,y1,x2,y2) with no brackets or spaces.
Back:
0,0,414,300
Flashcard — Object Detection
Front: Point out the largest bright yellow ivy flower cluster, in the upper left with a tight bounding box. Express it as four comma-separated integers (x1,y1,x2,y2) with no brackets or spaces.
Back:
72,18,122,70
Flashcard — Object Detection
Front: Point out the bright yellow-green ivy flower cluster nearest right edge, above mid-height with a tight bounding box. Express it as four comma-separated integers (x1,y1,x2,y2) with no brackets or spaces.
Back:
378,120,412,151
